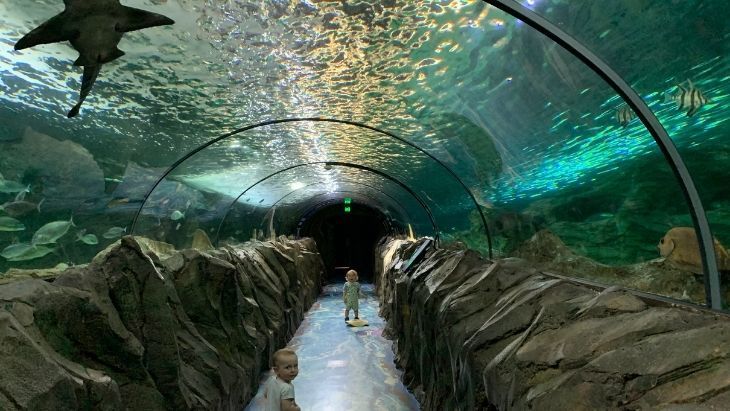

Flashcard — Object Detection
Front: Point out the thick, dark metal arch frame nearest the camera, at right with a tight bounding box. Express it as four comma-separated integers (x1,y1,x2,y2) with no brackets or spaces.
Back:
483,0,722,310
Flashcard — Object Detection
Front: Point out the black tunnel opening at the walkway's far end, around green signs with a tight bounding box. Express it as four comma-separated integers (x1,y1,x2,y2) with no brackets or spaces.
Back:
299,204,391,283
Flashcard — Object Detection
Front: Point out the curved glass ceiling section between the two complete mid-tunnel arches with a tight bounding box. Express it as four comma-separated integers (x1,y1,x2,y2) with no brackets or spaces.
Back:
132,118,491,255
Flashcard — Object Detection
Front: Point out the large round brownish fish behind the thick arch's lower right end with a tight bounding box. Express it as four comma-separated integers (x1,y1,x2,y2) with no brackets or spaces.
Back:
657,227,730,274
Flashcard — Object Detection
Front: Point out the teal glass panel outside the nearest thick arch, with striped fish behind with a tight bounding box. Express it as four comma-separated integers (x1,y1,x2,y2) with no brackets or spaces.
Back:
521,0,730,307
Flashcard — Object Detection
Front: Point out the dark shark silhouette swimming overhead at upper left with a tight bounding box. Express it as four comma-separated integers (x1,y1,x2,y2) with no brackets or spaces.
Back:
15,0,175,118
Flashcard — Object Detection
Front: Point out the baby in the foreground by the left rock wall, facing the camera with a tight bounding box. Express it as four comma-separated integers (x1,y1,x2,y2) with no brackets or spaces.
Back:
264,348,300,411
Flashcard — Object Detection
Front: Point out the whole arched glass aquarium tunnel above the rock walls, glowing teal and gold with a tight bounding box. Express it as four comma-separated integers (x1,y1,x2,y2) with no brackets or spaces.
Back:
0,0,730,318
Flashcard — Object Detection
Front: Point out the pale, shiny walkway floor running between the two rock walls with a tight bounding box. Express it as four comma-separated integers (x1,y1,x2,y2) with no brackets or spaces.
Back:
246,284,420,411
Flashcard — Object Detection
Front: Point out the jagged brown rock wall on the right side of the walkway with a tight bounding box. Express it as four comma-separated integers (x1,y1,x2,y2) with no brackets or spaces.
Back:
378,240,730,411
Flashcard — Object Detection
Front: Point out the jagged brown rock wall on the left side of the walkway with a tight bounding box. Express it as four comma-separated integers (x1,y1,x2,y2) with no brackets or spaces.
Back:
0,236,323,410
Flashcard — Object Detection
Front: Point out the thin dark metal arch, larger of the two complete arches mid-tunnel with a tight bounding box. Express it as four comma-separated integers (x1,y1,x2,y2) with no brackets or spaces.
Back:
130,117,493,259
